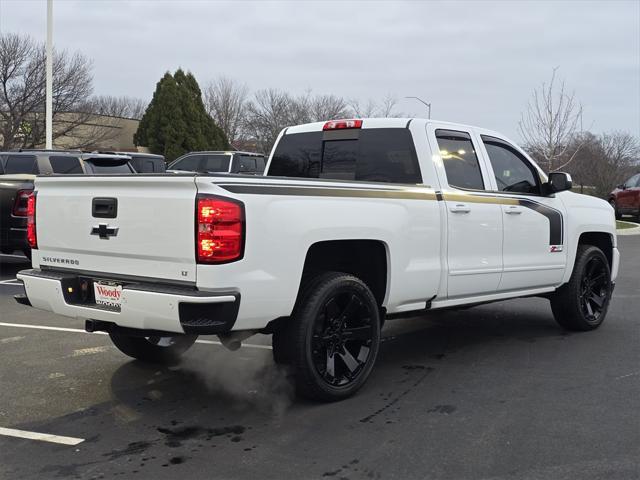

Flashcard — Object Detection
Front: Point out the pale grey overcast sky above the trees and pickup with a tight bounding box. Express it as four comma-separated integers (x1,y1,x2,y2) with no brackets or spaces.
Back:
0,0,640,140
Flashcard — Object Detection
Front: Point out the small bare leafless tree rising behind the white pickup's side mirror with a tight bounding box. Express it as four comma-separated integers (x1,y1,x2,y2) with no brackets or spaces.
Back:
519,67,582,171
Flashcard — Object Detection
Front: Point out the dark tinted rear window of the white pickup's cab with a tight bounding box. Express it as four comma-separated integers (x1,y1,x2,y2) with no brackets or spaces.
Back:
267,128,422,183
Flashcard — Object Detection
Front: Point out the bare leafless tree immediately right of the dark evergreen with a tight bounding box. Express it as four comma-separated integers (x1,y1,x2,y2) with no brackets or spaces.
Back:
204,77,249,145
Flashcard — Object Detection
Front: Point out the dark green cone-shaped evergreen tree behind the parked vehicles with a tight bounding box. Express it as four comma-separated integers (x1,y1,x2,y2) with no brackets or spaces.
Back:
133,69,229,161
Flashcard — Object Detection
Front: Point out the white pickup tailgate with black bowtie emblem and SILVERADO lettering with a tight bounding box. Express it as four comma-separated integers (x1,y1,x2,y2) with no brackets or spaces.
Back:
33,176,196,282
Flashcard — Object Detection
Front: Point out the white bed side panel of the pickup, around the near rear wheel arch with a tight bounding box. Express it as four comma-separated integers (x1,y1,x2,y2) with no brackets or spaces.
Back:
197,177,441,330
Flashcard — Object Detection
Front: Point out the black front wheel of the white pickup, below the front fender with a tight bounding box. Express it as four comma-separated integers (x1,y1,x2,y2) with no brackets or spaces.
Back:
551,245,611,331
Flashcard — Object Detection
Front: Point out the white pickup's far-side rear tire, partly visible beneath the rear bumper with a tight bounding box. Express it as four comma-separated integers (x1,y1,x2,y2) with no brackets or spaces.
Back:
109,333,198,364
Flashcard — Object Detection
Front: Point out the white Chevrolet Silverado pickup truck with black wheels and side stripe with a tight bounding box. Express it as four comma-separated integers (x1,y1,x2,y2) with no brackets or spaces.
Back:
17,119,619,401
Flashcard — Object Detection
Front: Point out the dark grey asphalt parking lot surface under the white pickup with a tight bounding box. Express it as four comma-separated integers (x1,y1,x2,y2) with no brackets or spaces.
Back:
0,236,640,480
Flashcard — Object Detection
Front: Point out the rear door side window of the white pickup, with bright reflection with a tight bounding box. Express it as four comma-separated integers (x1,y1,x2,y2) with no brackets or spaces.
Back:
436,130,484,190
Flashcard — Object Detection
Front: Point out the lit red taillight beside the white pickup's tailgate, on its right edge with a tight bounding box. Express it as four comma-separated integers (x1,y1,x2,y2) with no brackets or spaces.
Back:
196,195,244,263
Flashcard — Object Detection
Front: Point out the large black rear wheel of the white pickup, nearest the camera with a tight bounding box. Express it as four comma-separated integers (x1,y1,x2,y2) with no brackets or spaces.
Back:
273,272,380,401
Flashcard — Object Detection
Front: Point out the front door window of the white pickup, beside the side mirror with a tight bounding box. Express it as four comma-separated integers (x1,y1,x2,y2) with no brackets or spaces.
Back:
482,135,540,194
